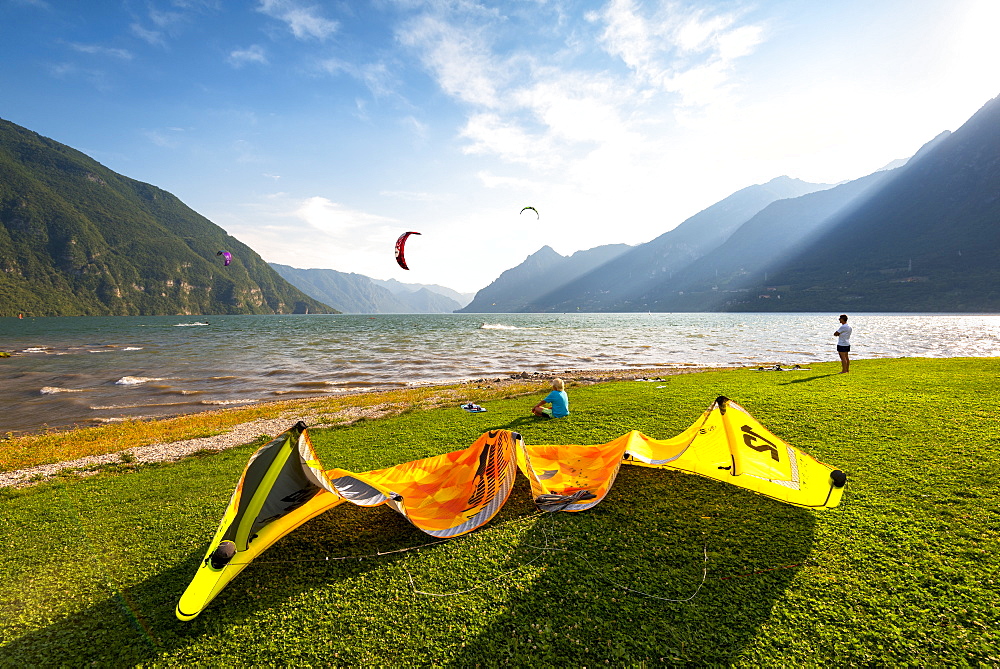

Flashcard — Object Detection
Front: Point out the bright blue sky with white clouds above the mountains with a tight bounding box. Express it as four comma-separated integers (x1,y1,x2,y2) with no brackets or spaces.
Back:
0,0,1000,293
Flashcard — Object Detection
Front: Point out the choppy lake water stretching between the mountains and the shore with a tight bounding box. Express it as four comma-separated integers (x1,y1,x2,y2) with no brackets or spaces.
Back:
0,313,1000,433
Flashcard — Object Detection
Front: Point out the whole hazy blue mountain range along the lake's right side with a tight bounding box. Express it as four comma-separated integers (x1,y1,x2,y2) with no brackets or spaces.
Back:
462,98,1000,312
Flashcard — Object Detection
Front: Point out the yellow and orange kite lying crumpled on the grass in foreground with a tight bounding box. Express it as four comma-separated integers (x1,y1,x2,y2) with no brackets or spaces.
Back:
176,396,847,620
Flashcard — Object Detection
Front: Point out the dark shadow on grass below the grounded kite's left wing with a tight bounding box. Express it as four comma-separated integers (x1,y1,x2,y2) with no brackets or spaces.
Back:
0,498,446,667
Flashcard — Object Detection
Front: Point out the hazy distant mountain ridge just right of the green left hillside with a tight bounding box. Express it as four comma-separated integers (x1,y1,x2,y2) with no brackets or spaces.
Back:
270,263,462,314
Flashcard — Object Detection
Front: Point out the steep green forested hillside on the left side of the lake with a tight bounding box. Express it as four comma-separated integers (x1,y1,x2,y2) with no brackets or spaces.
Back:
0,119,335,316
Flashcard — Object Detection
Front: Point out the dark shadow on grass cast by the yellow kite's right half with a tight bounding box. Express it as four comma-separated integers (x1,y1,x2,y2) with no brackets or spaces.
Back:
448,466,815,666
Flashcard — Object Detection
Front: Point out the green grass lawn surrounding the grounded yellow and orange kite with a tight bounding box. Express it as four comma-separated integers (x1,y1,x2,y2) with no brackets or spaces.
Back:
0,358,1000,667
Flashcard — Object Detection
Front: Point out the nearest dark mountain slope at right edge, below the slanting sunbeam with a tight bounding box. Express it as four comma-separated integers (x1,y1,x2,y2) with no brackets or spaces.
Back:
739,97,1000,312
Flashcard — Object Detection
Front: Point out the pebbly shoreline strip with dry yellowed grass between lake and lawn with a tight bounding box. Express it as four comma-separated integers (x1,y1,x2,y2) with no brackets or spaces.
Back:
0,365,724,488
